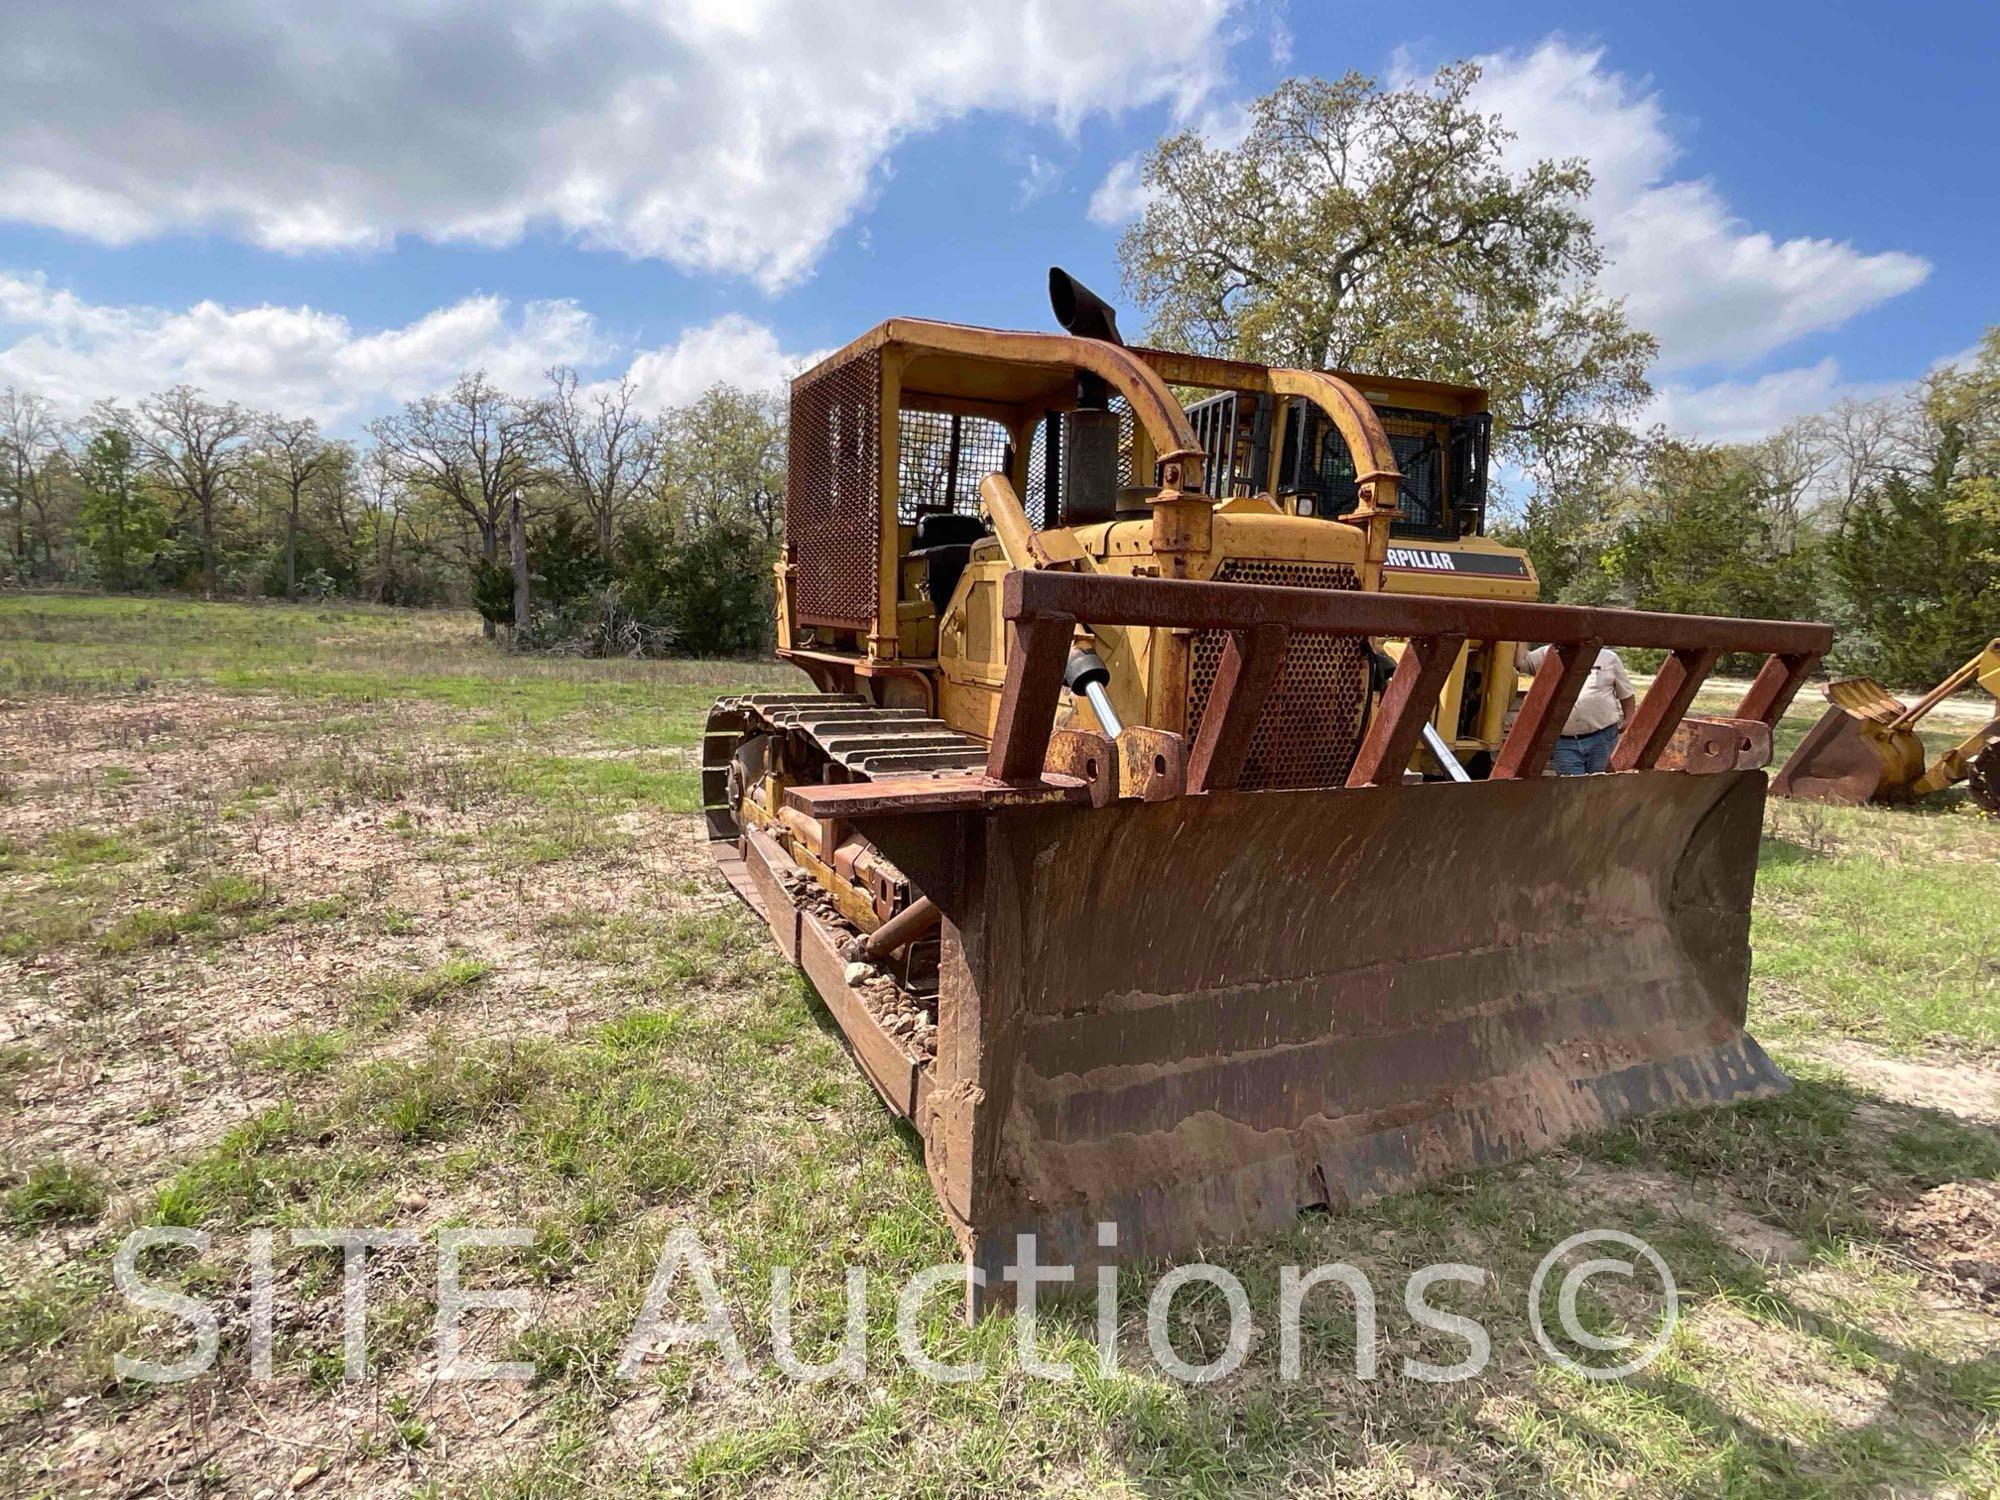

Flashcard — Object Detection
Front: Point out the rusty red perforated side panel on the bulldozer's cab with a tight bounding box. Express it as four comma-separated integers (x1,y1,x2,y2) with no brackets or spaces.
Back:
784,352,882,630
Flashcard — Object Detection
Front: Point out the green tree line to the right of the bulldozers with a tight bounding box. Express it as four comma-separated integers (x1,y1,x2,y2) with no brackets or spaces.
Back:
1500,328,2000,688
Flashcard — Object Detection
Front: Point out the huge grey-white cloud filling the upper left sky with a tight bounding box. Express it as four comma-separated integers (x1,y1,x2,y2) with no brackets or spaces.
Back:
0,0,1234,290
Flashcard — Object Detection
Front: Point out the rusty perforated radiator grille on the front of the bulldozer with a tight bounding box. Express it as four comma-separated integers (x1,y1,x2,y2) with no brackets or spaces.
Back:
1188,558,1368,792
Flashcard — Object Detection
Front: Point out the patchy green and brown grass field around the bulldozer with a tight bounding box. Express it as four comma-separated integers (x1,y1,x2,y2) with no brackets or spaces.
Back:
0,596,2000,1496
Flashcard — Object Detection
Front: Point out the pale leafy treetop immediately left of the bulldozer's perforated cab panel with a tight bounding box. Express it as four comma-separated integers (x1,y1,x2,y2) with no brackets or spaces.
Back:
660,382,786,544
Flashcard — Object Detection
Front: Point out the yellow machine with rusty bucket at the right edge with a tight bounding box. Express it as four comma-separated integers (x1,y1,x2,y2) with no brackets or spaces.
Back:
1772,638,2000,812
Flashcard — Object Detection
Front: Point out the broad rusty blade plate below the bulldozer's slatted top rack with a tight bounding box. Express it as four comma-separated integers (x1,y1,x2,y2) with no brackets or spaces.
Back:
848,770,1786,1278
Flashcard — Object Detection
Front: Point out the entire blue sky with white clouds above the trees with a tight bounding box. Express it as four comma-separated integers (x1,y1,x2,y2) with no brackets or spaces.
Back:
0,0,2000,452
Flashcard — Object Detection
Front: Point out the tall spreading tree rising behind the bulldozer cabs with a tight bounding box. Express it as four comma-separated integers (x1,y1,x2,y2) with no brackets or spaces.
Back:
1120,62,1658,494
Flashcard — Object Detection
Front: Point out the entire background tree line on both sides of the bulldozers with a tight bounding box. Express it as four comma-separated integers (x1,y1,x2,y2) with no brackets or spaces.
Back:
0,338,2000,686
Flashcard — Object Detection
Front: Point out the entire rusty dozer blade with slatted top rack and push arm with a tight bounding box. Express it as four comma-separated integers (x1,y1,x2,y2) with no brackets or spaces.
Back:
718,570,1832,1308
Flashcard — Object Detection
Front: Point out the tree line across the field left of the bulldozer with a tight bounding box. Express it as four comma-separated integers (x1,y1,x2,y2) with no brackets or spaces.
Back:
0,366,784,656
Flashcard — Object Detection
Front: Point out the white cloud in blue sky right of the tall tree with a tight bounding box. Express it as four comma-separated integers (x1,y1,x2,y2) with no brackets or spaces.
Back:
1476,38,1930,378
